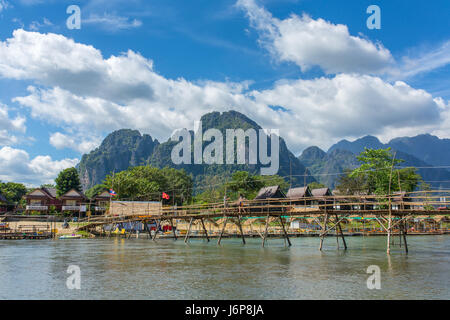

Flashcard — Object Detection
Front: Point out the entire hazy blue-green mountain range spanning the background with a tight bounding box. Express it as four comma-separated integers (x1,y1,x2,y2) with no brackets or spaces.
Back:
77,111,450,189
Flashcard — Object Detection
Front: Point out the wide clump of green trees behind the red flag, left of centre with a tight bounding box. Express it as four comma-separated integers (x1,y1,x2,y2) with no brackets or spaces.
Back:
104,166,192,204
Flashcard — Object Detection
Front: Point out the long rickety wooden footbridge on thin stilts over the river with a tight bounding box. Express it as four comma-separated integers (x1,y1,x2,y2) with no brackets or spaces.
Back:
78,190,450,253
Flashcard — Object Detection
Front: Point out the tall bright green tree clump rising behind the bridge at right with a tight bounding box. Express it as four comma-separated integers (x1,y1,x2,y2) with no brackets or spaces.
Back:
344,148,421,194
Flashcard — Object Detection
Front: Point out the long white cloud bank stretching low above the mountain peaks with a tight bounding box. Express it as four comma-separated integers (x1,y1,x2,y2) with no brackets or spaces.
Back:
0,30,449,153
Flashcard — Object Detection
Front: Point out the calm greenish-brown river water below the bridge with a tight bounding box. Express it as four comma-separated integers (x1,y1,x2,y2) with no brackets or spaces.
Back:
0,235,450,300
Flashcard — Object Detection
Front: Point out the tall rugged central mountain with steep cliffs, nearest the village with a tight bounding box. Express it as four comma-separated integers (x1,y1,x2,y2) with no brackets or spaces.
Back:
78,111,315,189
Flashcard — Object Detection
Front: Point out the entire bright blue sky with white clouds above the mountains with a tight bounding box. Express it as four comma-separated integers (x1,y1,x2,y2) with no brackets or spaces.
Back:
0,0,450,184
